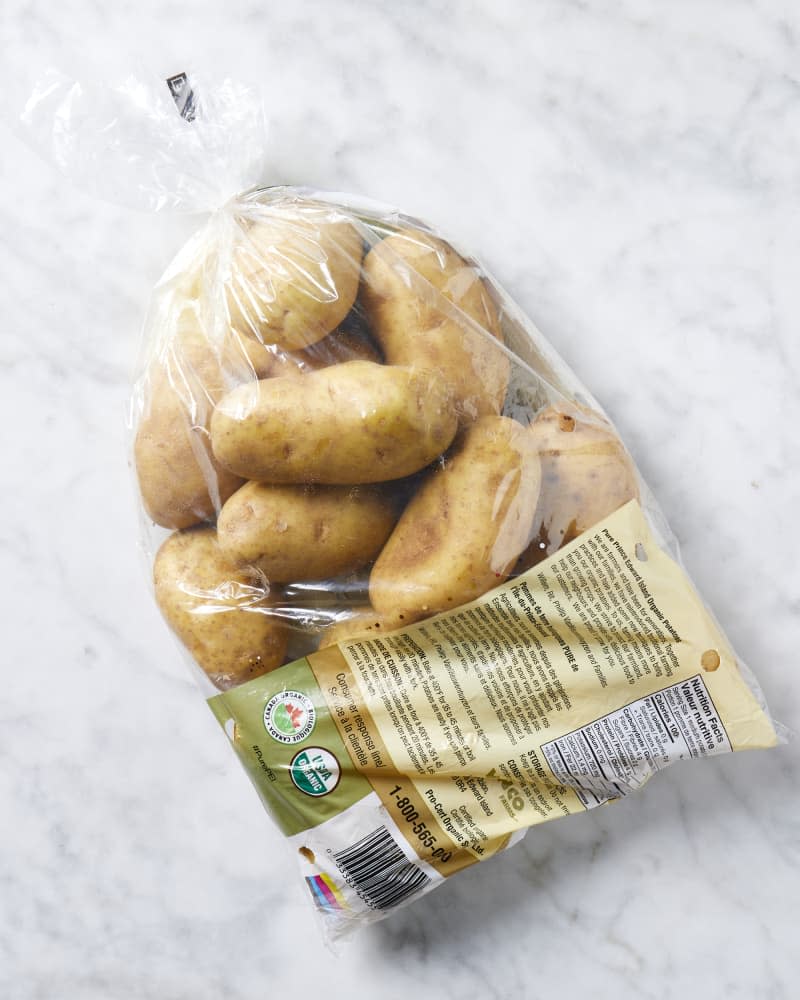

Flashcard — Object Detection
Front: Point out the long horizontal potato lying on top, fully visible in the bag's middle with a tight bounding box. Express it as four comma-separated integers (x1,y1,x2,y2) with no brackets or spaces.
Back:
211,361,456,485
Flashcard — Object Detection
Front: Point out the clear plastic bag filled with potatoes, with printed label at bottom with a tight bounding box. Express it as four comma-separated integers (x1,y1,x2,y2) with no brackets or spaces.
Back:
20,66,776,937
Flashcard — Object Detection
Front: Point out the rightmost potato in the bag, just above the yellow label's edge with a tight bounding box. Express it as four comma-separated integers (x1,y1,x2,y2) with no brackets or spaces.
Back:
517,406,639,573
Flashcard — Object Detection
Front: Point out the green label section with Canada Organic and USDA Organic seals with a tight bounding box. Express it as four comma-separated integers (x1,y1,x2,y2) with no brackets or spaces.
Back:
208,659,372,836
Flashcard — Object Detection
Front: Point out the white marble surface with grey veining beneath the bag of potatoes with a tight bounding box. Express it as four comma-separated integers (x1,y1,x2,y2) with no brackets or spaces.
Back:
0,0,800,1000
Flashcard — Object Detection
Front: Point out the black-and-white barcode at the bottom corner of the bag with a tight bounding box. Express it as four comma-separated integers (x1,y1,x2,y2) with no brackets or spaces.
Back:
332,826,430,910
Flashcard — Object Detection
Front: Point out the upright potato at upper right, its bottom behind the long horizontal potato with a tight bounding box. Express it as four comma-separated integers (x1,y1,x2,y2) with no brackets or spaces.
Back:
362,229,510,424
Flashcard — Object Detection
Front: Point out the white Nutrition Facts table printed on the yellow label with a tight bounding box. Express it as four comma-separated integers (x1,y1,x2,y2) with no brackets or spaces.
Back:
542,674,731,809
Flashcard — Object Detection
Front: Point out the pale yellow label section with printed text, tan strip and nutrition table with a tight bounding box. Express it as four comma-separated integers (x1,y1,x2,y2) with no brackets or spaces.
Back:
309,501,776,874
